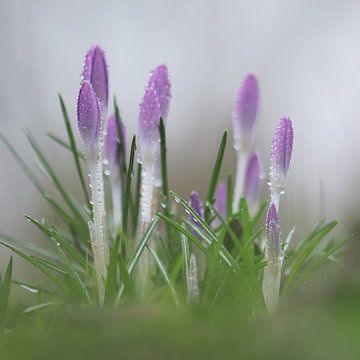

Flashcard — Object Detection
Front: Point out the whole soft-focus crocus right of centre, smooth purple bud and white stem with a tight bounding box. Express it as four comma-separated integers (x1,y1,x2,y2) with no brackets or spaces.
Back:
233,74,259,212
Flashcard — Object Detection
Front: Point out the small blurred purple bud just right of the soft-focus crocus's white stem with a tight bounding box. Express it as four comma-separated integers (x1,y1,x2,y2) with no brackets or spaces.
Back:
244,153,261,204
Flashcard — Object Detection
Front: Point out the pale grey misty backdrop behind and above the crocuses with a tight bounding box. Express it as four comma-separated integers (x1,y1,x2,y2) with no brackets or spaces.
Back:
0,0,360,268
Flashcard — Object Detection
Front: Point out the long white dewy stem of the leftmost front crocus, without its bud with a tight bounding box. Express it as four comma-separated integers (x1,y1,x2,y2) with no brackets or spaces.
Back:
89,156,109,301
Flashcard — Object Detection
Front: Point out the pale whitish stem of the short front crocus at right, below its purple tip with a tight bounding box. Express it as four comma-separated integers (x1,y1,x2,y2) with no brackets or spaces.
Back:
262,250,282,313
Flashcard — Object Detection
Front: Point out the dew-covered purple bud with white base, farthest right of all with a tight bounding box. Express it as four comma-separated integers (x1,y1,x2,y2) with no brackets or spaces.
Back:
269,117,294,210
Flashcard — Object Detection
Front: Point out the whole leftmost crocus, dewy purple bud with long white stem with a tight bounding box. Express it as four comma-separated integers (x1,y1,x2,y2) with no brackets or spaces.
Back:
77,81,108,300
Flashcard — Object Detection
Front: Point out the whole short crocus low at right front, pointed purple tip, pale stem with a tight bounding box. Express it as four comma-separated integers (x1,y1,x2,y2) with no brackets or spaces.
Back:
262,204,282,312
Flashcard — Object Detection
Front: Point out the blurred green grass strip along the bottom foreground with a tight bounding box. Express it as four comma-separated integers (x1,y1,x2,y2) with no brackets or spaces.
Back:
1,262,360,360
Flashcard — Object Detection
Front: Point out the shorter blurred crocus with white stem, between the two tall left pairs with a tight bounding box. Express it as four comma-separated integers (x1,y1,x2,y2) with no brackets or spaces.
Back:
105,114,126,234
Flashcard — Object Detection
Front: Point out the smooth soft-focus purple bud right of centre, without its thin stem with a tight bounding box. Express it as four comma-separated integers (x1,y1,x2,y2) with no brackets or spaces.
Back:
233,74,259,151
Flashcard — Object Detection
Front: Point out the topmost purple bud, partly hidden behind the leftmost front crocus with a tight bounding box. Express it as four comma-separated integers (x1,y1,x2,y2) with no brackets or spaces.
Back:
82,46,109,117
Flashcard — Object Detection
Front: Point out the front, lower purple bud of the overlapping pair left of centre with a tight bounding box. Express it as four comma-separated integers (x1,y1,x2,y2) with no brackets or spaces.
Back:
138,87,160,166
